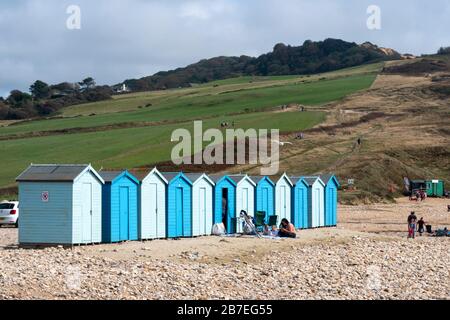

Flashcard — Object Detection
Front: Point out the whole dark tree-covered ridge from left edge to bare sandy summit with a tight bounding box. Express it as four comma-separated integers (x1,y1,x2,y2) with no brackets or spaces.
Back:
0,39,401,120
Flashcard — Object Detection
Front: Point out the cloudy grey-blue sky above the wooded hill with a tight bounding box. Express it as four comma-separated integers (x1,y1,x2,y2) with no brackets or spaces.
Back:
0,0,450,96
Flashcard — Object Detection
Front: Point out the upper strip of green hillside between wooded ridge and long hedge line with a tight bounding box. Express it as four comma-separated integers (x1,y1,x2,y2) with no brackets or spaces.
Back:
0,73,376,137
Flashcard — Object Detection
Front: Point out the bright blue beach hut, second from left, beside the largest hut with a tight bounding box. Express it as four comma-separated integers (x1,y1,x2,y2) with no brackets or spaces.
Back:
100,171,139,243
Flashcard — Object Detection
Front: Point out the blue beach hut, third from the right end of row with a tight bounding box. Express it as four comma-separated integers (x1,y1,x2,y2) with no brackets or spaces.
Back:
290,177,312,229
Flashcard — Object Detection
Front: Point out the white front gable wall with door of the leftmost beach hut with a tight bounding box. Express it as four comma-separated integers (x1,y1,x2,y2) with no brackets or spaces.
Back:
72,171,102,244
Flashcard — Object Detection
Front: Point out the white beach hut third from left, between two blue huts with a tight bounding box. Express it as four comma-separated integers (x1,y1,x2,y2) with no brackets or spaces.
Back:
133,168,169,240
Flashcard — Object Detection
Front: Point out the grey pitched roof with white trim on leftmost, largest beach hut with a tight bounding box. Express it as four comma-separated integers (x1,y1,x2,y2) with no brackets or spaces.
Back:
16,164,105,183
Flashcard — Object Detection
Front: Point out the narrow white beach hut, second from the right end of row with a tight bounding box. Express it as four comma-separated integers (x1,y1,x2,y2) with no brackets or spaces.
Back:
304,177,325,228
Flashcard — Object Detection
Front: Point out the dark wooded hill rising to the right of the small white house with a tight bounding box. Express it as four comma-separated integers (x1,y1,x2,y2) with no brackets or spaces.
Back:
122,39,401,91
